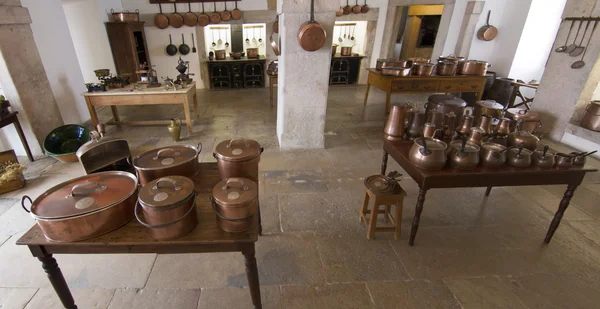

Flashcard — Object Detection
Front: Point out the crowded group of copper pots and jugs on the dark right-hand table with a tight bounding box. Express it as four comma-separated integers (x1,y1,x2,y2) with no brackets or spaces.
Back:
384,95,595,170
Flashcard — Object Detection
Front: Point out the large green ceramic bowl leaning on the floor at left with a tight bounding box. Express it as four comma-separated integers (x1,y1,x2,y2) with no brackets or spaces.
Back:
44,124,90,162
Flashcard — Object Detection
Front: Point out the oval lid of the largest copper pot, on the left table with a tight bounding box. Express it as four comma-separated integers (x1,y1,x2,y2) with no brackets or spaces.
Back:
31,171,137,219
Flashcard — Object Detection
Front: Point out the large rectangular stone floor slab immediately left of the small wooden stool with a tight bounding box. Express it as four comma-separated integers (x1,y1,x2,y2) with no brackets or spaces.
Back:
279,191,360,232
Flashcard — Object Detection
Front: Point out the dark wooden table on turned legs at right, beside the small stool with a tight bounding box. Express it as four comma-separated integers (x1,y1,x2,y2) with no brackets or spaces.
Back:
381,140,598,246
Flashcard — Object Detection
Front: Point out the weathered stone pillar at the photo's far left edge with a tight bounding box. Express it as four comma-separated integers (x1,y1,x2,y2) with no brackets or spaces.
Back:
0,0,63,155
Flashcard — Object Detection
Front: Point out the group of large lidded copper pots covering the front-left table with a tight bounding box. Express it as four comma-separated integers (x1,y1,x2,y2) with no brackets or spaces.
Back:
21,128,263,242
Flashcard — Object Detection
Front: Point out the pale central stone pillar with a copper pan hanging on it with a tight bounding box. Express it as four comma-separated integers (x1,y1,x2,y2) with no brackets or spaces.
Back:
277,0,339,150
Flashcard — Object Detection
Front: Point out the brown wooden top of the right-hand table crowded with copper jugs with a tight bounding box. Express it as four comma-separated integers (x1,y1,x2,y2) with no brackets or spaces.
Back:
383,140,598,189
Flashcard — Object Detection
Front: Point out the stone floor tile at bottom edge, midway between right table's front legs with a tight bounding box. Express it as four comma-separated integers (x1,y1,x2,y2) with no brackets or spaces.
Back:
444,277,527,309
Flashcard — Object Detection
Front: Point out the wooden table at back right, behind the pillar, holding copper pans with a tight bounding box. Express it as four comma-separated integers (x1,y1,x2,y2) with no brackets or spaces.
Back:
365,68,487,112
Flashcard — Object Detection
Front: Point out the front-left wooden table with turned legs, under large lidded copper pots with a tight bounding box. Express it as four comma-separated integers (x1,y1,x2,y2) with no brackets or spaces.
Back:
17,163,262,309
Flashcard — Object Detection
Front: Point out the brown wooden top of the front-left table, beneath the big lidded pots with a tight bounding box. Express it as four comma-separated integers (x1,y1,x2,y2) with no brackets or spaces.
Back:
17,163,258,253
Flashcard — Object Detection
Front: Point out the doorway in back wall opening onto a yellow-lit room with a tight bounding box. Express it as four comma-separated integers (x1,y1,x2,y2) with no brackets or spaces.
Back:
394,5,444,59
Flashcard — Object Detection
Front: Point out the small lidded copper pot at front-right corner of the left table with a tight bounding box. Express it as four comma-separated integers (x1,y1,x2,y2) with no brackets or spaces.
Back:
212,178,258,233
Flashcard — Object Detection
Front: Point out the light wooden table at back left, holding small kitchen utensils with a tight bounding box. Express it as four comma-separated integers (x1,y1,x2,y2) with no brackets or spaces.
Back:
82,82,199,134
